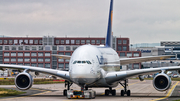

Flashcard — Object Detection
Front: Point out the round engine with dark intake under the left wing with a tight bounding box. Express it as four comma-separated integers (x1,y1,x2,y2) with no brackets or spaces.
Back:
14,72,33,90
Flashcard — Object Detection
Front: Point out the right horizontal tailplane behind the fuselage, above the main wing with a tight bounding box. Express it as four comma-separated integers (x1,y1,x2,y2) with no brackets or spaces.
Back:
120,55,174,65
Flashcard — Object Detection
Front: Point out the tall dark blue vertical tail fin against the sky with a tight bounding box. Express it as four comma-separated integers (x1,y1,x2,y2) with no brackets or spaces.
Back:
106,0,113,47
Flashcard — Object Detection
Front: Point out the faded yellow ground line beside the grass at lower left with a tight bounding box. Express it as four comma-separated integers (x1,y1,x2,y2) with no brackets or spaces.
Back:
0,88,52,100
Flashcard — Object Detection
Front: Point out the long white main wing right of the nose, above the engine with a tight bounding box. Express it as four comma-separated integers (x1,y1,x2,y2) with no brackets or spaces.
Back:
105,66,180,84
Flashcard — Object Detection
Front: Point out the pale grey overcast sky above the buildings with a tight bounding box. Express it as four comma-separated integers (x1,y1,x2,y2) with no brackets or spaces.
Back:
0,0,180,43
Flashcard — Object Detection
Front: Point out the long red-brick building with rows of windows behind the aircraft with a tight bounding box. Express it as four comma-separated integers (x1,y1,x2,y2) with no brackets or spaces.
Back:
0,36,141,70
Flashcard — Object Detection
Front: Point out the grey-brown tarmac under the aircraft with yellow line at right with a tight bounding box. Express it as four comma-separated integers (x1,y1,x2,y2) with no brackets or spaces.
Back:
0,80,180,101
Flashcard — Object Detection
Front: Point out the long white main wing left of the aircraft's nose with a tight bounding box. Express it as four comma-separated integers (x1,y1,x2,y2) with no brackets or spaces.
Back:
0,64,71,81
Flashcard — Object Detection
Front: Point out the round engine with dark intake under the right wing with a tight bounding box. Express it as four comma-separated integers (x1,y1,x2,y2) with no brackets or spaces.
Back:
153,73,171,91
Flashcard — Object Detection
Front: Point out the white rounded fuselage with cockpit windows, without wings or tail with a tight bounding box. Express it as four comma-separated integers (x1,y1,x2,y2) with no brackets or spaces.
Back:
69,45,120,87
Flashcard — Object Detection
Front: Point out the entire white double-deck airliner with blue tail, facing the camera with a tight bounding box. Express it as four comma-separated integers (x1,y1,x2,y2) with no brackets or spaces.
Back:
0,0,180,96
